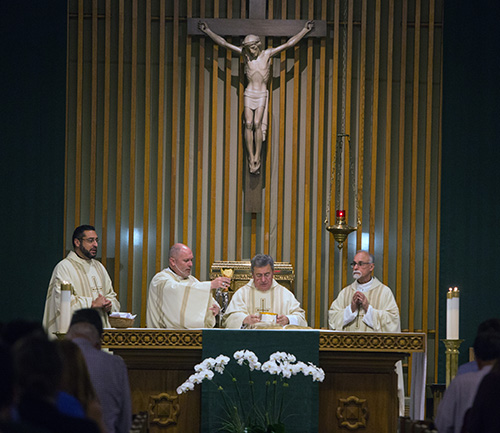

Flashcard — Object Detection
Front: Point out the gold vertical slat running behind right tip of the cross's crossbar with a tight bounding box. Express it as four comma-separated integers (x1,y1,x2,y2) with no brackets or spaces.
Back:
314,0,326,328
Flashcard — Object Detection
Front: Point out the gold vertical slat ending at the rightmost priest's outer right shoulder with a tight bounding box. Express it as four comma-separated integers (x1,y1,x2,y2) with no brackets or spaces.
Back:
396,0,408,314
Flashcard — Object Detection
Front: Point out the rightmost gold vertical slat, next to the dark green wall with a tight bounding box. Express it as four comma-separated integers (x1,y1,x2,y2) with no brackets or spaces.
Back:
422,0,434,332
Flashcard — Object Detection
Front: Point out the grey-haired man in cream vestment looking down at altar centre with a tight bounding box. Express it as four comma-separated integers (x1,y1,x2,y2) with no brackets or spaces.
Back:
223,254,307,329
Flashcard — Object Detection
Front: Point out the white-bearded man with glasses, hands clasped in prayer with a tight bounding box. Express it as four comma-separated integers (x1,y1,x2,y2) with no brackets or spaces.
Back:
328,251,404,416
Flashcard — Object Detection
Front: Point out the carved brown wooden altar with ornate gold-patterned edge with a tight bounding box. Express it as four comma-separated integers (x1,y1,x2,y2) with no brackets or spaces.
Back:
103,328,426,433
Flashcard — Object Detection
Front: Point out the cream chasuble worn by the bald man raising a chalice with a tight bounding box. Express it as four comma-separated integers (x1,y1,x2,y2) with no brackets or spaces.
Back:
146,268,217,329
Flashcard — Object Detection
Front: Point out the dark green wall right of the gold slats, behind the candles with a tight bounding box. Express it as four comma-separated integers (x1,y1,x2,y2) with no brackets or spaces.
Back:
439,0,500,381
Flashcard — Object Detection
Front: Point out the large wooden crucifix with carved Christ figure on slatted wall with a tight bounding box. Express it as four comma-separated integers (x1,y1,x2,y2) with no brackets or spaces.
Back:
188,0,326,213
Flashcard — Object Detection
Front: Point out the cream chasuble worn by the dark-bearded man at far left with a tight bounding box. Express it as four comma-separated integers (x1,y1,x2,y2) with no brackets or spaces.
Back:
43,251,120,338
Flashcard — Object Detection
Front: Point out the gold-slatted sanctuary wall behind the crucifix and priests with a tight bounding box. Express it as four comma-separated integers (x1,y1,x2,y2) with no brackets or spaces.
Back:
63,0,443,381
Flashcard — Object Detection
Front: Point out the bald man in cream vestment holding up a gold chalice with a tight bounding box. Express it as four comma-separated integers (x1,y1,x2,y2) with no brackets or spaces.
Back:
146,243,231,329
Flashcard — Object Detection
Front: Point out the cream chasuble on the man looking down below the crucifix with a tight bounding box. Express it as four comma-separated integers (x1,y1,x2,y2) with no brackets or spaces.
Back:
223,279,307,329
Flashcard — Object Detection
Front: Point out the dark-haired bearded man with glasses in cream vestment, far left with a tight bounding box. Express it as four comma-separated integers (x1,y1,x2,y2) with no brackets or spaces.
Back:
43,225,120,338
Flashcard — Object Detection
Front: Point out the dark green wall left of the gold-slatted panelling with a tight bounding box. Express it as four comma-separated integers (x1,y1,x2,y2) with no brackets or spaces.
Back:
0,0,66,322
